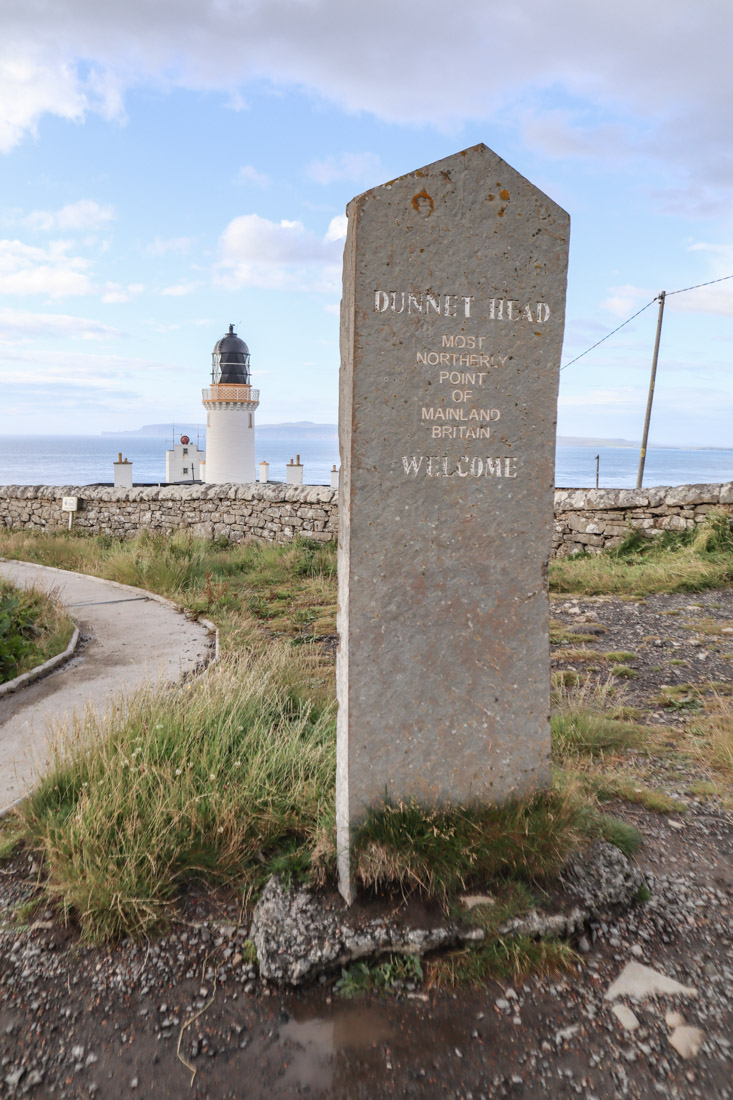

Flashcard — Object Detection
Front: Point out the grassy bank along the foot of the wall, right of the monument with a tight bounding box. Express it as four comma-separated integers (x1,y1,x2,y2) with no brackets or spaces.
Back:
549,512,733,596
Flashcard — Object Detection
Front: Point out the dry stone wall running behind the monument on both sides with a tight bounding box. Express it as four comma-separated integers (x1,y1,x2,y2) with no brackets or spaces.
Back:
0,482,733,557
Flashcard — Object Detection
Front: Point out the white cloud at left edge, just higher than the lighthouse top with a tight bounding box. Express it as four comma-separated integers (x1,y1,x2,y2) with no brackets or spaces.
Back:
0,240,92,298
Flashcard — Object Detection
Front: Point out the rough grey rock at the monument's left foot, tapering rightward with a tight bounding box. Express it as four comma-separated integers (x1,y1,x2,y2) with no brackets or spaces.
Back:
250,876,484,986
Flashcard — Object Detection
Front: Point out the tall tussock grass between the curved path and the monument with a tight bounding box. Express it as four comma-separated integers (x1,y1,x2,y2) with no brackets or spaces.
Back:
20,646,335,939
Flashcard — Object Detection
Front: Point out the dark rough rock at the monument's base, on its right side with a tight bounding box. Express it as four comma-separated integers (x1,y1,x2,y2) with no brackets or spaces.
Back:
499,840,646,939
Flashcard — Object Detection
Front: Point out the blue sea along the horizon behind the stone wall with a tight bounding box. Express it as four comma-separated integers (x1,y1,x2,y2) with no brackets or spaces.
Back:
0,427,733,488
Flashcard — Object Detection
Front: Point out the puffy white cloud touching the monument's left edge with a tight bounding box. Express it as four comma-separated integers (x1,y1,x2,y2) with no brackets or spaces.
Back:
218,213,342,290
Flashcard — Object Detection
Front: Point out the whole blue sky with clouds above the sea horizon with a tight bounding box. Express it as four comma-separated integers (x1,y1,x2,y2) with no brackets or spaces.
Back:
0,0,733,447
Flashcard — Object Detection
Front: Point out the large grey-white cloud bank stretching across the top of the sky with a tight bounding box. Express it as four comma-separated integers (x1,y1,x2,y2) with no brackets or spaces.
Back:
0,0,733,204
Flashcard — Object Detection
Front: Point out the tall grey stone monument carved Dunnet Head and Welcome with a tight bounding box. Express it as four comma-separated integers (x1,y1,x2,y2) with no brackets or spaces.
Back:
337,145,570,901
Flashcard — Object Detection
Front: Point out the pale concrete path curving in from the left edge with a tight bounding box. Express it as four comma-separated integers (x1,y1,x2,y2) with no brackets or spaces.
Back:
0,561,215,812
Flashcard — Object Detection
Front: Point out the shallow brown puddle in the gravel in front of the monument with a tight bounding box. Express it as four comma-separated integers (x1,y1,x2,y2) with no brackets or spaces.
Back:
280,1005,395,1091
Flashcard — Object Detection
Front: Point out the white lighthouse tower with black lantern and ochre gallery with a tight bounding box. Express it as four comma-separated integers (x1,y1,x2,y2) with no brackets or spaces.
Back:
201,325,260,484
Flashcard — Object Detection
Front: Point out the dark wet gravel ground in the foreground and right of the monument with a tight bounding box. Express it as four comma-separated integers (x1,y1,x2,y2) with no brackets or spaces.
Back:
0,591,733,1100
